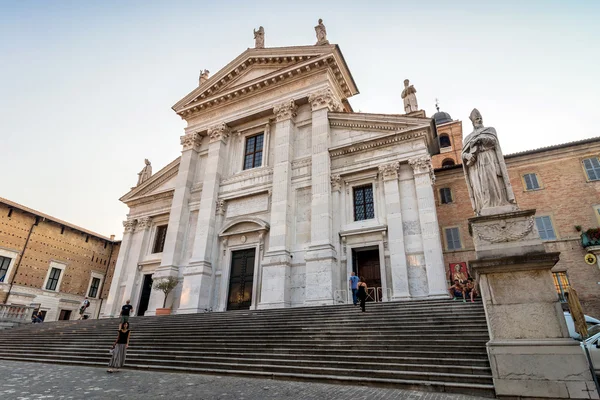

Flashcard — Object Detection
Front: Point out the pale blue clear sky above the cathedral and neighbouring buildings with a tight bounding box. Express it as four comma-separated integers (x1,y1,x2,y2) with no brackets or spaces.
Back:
0,0,600,238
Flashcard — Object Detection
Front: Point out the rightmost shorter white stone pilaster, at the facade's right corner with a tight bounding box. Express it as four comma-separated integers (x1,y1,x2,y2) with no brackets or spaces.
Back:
408,155,448,297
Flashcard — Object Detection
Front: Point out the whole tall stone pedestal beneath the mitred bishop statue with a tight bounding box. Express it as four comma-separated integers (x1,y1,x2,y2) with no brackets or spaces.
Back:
469,210,598,399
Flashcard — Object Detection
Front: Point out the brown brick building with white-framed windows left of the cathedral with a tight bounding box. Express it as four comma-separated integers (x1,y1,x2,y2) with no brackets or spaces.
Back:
0,198,120,321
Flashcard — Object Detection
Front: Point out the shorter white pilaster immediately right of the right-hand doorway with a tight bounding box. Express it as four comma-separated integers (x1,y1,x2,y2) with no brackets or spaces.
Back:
379,161,410,300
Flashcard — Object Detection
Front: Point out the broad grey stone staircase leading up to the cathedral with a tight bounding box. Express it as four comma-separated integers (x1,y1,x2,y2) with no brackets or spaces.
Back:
0,300,495,397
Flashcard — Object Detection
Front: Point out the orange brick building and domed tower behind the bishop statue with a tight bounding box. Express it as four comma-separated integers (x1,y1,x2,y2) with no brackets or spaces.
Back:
432,112,600,317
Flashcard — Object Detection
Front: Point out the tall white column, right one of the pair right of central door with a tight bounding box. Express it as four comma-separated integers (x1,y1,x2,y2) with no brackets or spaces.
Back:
305,88,343,305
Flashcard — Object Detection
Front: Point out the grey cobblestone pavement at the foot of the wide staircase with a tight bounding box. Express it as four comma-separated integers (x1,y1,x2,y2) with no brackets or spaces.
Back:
0,360,488,400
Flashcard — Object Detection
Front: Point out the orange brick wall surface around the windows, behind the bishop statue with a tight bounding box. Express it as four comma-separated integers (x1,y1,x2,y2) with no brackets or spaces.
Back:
435,140,600,317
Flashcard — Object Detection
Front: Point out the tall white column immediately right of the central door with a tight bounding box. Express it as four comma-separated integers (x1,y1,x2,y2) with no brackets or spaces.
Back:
258,100,298,309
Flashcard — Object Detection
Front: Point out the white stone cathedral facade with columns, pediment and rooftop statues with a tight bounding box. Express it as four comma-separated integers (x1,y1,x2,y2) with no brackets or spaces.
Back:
103,42,447,316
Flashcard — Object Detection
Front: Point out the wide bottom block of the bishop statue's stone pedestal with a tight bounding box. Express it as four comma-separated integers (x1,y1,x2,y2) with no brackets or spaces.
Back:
487,339,598,399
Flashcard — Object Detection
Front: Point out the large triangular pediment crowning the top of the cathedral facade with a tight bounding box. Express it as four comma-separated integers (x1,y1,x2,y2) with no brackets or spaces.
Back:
173,45,358,117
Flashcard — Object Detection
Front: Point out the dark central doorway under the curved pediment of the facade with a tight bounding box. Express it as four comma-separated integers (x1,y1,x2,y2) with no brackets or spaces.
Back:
227,249,256,310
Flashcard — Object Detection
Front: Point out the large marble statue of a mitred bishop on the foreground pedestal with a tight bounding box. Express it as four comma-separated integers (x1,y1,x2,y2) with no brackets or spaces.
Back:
461,108,518,216
